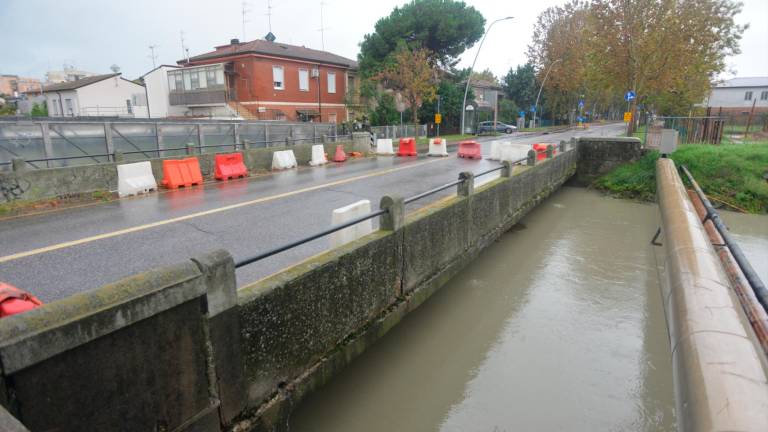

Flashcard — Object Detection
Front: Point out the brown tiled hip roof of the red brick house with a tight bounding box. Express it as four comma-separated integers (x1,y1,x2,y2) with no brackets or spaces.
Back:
184,39,357,69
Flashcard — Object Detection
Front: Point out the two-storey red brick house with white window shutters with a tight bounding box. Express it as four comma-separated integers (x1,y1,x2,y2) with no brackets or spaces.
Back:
178,39,357,123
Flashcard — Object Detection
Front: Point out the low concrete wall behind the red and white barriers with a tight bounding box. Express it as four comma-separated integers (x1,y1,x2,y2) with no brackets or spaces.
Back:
0,134,370,204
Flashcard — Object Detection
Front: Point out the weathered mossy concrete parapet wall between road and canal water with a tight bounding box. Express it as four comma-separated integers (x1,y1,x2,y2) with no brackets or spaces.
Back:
0,139,640,431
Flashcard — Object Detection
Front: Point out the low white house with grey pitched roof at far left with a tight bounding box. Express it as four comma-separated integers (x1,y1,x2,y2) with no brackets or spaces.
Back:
43,73,149,118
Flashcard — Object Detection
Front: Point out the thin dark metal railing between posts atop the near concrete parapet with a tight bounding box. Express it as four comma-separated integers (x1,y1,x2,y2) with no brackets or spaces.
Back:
235,150,529,268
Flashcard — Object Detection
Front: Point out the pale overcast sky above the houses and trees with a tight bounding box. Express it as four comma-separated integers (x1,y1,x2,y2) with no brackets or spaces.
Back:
0,0,768,79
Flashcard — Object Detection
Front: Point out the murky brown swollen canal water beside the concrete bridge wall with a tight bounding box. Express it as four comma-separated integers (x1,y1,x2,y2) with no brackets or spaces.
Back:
289,187,768,432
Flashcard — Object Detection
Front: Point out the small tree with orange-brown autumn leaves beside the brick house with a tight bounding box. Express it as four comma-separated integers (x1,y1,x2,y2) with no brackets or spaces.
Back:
374,46,437,123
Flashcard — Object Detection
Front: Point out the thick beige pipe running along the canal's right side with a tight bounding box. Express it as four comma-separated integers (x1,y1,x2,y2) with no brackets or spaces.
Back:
656,159,768,431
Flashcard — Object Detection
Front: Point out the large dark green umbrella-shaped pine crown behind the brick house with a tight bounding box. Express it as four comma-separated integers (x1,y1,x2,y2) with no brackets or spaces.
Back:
358,0,485,77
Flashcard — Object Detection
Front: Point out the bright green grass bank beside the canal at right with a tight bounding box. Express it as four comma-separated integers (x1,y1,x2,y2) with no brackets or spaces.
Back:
593,143,768,214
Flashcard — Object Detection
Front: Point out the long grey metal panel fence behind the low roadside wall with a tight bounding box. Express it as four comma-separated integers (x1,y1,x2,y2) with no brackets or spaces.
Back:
0,120,347,170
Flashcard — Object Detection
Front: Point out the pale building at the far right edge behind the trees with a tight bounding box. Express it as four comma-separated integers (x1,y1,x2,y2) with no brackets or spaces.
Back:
707,77,768,114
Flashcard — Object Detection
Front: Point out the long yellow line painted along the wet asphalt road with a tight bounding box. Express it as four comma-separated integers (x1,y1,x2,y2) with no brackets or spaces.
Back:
0,158,449,263
